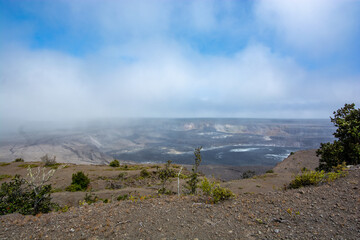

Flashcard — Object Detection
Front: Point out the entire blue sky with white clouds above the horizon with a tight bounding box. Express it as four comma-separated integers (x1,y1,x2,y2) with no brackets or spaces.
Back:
0,0,360,122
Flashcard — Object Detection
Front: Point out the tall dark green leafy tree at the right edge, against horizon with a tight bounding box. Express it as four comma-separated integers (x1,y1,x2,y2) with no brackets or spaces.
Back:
316,103,360,171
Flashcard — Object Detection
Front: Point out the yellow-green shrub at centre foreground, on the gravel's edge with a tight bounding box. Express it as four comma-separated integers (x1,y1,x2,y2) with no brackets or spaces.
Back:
200,177,234,203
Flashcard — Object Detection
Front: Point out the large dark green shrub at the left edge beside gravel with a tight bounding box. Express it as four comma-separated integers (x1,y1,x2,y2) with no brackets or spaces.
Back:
0,175,56,215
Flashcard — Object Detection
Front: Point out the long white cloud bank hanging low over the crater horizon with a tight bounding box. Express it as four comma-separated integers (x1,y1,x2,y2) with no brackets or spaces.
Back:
0,40,340,120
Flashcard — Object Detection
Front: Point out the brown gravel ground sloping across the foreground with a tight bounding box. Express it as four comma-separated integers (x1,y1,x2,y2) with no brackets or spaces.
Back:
0,166,360,239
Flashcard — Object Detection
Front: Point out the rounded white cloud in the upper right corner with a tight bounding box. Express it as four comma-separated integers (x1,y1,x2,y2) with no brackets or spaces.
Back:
256,0,359,57
